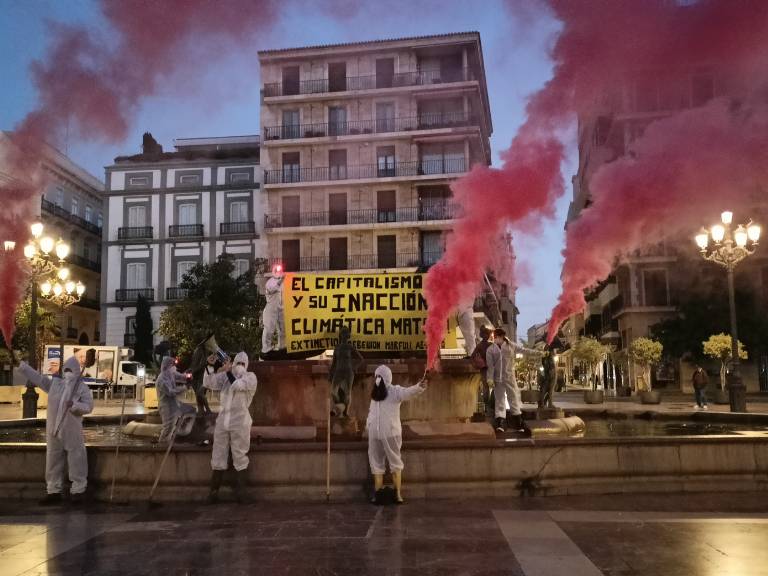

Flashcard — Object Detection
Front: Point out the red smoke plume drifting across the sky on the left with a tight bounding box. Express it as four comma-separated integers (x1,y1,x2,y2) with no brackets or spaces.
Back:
0,0,332,342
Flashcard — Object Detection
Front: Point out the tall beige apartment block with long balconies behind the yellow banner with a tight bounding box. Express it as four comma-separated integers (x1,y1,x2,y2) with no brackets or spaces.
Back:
259,32,514,336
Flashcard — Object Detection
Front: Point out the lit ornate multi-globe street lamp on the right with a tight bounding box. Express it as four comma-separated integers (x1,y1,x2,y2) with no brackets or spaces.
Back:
696,211,761,412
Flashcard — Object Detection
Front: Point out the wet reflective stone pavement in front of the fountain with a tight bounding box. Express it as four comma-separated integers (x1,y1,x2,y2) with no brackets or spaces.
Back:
0,493,768,576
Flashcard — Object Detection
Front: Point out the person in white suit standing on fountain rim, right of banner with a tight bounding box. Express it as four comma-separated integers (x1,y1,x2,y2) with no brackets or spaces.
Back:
485,328,523,432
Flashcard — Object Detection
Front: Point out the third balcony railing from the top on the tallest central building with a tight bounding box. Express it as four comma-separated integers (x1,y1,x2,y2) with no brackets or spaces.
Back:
264,157,467,184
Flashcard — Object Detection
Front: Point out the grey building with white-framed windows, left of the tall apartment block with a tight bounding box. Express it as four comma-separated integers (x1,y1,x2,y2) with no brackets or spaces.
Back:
101,134,266,346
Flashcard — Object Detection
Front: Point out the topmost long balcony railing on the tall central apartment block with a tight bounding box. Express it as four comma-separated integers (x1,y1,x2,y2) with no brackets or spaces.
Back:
263,68,476,98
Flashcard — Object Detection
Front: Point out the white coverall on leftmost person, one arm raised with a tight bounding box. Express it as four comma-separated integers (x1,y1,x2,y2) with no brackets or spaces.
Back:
19,356,93,494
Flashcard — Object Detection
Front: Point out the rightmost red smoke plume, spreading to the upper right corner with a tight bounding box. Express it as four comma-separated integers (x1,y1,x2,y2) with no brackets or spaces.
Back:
548,0,768,341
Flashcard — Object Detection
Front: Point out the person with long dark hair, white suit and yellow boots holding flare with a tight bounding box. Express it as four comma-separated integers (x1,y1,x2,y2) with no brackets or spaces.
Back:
365,365,427,504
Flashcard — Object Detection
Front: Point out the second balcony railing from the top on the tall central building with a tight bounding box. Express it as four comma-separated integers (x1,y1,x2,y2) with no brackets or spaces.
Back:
264,110,478,140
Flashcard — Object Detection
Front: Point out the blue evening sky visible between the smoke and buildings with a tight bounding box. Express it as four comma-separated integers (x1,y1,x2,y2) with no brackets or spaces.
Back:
0,0,575,337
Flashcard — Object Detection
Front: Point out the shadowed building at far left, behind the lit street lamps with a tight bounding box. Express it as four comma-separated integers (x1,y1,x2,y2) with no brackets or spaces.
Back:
0,132,104,344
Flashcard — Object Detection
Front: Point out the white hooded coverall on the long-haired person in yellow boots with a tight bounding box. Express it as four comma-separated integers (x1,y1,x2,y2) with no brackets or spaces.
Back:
365,366,424,474
